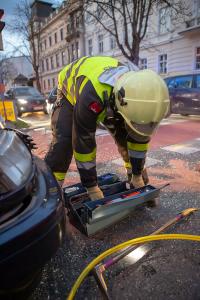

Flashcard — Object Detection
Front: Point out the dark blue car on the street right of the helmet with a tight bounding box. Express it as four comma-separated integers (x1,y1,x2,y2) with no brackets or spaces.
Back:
164,74,200,115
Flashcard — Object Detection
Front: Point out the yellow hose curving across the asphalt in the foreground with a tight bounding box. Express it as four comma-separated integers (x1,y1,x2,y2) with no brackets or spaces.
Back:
67,234,200,300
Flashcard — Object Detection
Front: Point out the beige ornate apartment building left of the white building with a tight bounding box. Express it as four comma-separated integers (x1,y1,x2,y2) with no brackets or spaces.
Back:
31,0,85,95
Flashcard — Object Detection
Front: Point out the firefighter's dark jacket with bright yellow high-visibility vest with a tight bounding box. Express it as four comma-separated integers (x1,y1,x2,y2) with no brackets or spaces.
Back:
54,57,148,187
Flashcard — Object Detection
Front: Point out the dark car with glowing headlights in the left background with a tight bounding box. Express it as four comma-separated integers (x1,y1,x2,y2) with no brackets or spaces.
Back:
4,86,47,116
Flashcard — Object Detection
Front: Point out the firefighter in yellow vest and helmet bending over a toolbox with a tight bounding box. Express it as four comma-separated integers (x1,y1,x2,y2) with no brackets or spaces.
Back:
45,56,169,200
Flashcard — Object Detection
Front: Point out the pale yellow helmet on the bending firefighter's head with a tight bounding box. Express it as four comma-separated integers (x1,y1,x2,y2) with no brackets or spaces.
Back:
114,70,170,136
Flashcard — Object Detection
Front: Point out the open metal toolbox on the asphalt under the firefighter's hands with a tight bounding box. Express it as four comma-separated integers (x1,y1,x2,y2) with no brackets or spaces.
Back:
64,173,166,236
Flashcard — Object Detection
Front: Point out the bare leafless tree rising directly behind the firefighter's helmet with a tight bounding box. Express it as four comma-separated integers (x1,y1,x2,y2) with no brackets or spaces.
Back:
84,0,190,64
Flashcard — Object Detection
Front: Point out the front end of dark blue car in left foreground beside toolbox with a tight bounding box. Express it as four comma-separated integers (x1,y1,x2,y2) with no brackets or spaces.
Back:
0,128,65,300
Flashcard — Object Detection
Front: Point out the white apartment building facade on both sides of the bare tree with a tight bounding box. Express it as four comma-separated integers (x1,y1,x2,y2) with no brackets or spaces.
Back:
85,0,200,77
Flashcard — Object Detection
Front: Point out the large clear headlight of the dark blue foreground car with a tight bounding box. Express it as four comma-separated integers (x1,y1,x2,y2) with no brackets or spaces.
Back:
0,129,32,195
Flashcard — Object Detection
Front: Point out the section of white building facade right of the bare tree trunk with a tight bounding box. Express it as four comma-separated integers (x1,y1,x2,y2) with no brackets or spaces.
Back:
140,0,200,77
